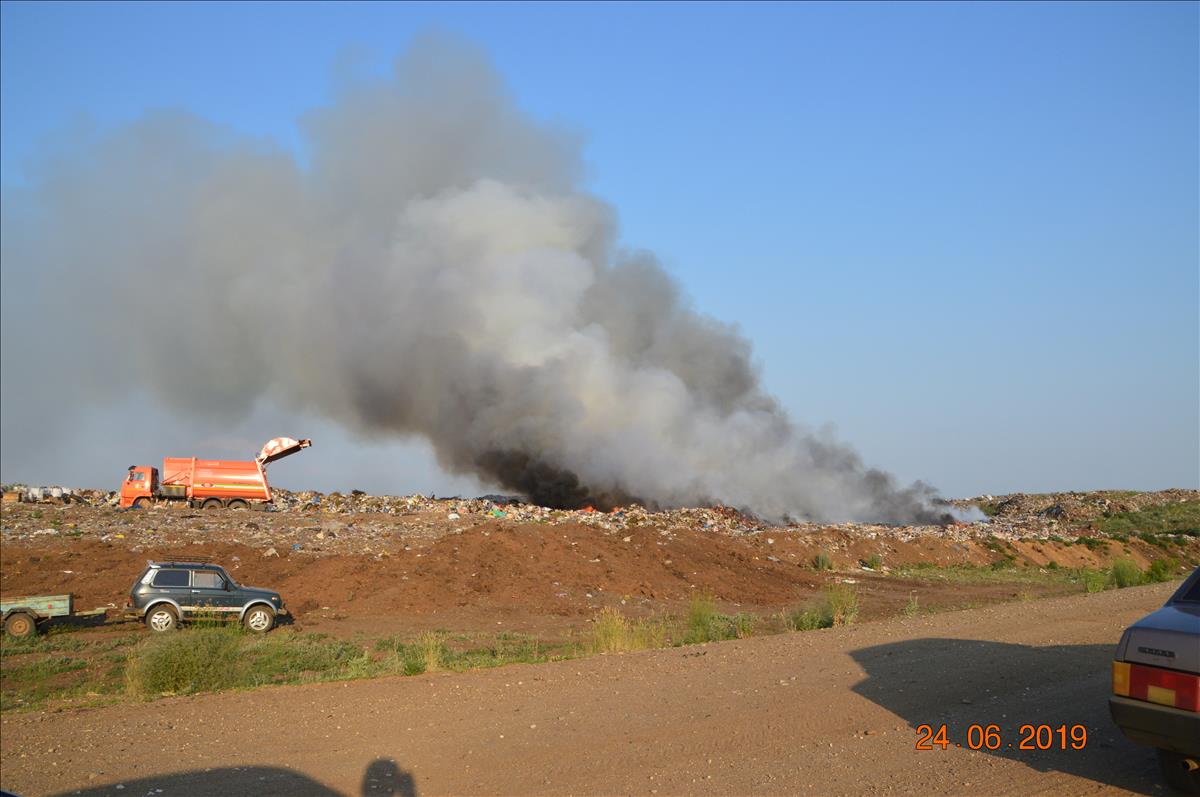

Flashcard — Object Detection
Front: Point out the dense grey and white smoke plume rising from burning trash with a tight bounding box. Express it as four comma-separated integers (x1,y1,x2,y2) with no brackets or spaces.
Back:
4,41,934,522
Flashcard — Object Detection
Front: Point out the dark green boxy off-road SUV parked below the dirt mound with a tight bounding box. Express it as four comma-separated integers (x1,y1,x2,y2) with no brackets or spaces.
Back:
128,562,288,634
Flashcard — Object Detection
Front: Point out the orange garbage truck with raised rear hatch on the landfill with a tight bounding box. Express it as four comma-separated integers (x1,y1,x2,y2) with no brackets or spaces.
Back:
120,437,312,509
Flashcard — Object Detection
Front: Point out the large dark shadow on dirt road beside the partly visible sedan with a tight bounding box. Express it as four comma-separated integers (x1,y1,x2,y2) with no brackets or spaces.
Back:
850,639,1165,795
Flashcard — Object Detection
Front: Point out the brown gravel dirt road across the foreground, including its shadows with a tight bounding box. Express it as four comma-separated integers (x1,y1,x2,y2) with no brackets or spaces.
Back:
0,585,1174,797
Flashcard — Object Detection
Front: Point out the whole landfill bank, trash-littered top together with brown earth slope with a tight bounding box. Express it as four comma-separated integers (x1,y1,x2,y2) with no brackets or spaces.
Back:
0,490,1200,634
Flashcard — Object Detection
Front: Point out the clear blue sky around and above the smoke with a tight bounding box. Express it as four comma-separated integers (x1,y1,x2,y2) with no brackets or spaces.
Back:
0,2,1200,495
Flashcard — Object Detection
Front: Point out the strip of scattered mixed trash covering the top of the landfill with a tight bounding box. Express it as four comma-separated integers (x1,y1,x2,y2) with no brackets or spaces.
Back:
0,486,1200,557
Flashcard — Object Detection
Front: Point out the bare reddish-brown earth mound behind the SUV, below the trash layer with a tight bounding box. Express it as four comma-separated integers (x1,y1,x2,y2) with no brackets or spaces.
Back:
0,525,822,615
